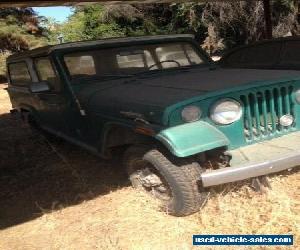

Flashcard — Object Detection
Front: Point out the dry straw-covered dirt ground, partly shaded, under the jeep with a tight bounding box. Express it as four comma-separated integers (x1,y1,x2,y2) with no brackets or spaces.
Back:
0,84,300,250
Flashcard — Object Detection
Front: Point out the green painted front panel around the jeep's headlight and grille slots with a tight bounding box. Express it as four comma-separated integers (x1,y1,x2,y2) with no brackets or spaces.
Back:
165,79,300,149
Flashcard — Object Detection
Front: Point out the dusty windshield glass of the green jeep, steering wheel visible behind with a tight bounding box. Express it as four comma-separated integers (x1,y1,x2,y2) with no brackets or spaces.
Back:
64,42,207,79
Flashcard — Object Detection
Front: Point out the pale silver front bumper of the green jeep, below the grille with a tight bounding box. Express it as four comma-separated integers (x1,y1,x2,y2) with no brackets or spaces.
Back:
200,132,300,187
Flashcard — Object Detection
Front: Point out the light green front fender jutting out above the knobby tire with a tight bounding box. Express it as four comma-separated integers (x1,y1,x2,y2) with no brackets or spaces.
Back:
155,121,229,157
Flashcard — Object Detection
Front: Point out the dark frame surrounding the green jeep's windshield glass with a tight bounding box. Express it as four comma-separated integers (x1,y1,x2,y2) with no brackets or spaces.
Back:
58,38,215,84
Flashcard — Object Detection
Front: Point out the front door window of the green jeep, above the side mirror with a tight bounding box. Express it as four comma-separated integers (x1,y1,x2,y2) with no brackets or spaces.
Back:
34,57,60,91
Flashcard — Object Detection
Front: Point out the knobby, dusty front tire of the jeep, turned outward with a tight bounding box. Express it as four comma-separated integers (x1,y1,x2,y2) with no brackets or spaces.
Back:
124,146,208,216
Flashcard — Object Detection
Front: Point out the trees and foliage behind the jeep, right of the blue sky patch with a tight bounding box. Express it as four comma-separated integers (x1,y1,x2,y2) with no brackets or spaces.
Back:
50,0,299,50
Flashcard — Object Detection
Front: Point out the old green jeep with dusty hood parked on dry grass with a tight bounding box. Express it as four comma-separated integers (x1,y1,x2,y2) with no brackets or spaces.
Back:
7,35,300,216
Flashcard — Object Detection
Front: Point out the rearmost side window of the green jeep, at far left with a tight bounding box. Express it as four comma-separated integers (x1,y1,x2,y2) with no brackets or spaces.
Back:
8,62,31,87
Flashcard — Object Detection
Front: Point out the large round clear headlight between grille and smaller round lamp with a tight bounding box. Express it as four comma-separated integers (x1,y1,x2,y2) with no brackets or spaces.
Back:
210,99,242,125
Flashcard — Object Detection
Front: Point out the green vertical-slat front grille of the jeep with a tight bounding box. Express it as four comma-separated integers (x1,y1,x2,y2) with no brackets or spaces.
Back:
240,85,295,141
